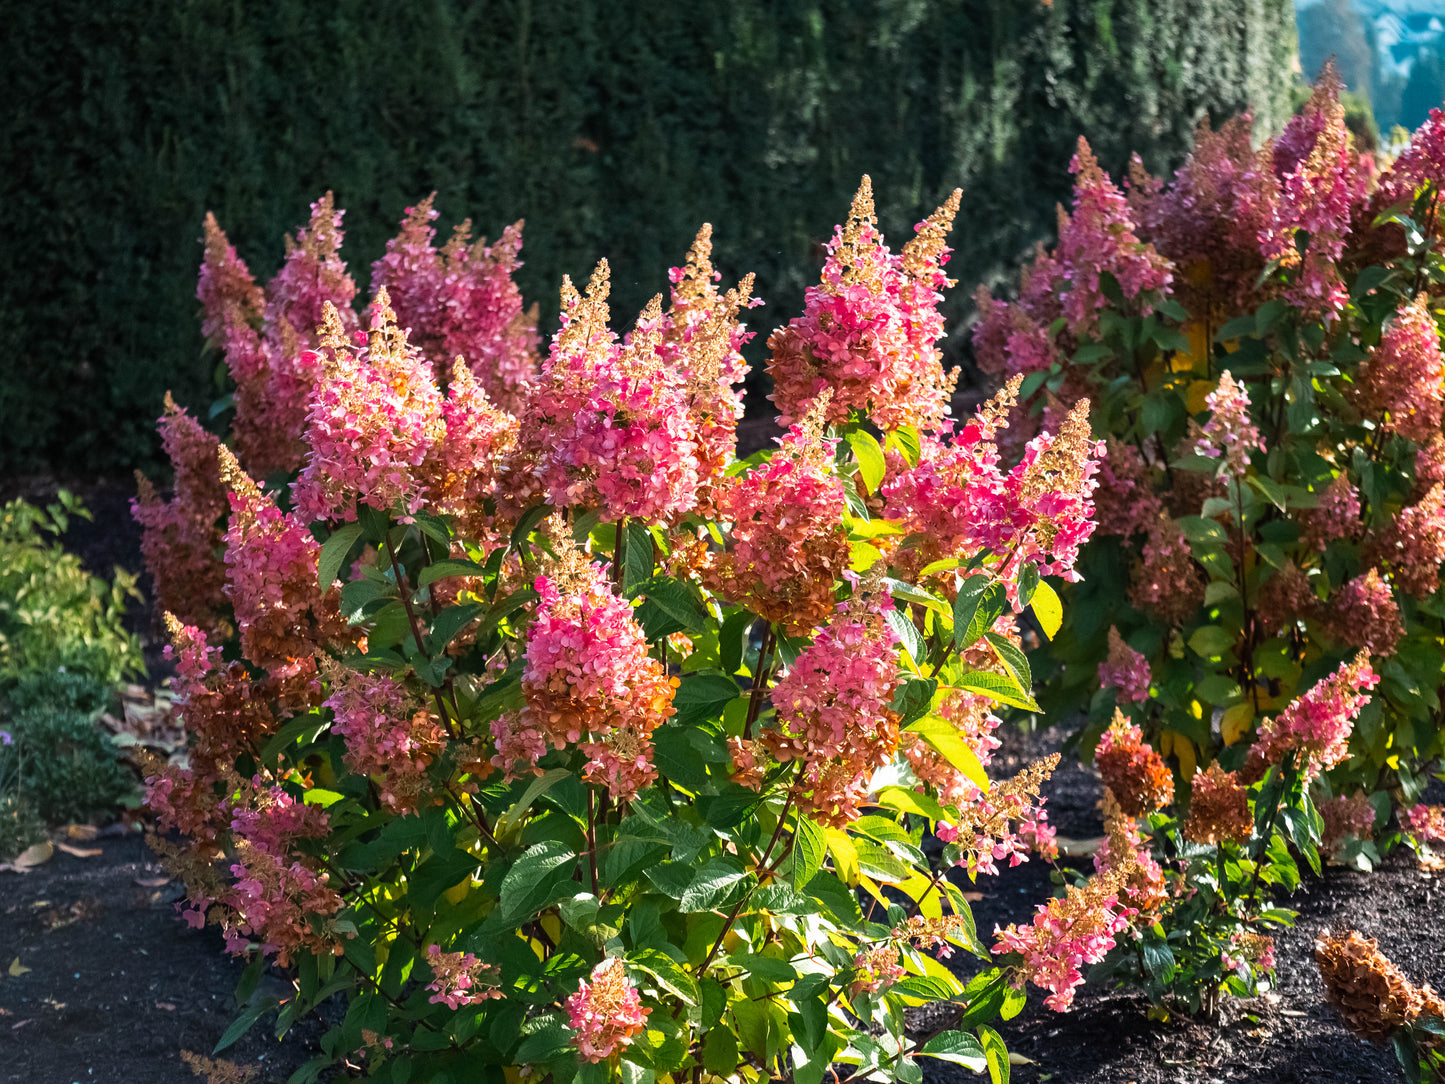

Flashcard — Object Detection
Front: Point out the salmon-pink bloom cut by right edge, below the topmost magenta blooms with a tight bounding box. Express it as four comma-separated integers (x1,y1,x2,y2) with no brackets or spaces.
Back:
1355,293,1445,444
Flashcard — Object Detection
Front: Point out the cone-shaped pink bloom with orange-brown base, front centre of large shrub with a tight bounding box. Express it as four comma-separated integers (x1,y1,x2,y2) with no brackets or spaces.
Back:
493,554,676,801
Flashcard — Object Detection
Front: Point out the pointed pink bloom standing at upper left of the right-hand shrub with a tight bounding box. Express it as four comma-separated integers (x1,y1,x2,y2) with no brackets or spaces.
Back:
1053,136,1173,335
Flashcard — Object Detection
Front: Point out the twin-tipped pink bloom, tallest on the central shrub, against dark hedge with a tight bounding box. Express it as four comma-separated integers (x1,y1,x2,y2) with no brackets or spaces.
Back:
767,176,961,431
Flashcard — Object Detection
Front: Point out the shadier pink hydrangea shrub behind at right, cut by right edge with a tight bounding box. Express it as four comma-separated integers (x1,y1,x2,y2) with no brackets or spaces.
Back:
974,69,1445,864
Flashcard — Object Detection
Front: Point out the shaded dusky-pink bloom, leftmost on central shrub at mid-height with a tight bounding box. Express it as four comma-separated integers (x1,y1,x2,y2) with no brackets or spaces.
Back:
130,392,227,632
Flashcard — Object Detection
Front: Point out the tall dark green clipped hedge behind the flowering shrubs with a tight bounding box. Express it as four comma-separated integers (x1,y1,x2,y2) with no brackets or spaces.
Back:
0,0,1295,473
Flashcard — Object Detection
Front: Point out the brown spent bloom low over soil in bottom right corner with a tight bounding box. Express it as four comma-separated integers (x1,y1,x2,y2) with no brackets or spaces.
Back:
1315,929,1445,1044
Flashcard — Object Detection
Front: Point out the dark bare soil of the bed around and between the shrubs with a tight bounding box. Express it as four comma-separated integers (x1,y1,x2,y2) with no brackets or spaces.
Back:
0,482,1445,1084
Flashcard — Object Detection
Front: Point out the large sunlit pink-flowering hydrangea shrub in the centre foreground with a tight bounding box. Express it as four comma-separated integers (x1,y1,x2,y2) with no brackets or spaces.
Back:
136,182,1136,1084
